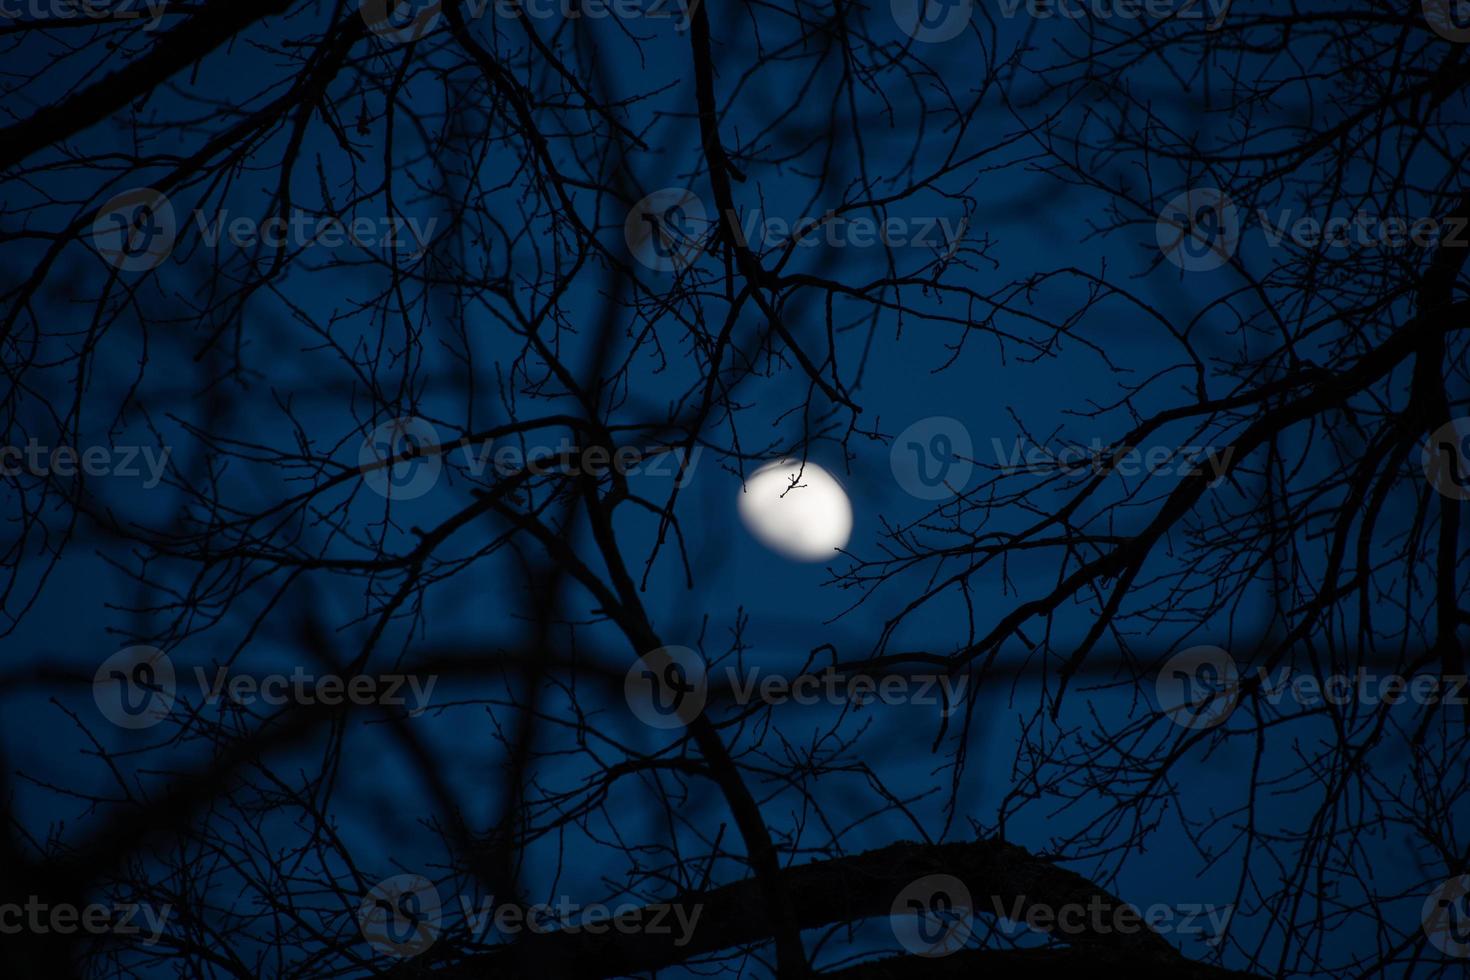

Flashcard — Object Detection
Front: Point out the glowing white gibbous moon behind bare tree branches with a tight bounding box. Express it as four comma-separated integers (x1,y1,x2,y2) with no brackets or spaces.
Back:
739,460,853,561
